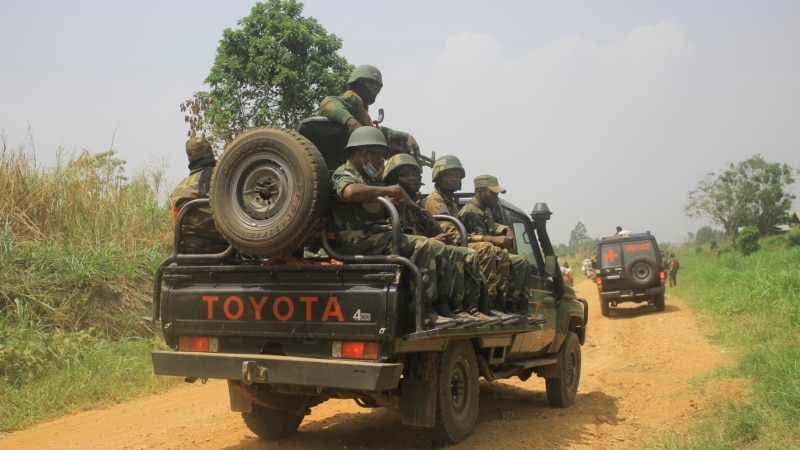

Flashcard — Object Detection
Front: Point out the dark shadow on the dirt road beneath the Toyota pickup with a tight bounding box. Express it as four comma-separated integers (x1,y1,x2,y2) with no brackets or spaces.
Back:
223,377,622,450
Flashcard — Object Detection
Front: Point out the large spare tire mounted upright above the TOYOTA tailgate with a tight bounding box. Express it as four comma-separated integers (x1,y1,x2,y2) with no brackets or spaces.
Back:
208,127,330,256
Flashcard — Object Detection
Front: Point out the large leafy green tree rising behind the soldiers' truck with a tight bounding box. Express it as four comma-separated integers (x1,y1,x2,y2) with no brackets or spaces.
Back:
188,0,353,143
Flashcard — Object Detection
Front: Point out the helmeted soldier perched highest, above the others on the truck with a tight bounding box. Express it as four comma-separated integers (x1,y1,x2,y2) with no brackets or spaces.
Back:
319,65,419,157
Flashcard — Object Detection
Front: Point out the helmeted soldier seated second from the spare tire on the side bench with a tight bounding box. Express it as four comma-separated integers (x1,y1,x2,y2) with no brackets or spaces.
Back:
383,153,500,326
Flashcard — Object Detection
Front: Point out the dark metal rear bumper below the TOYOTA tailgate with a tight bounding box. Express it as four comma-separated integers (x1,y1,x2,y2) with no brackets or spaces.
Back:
151,352,403,391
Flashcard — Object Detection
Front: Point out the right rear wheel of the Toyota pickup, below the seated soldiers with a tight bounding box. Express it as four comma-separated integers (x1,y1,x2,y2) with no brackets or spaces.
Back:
432,341,480,444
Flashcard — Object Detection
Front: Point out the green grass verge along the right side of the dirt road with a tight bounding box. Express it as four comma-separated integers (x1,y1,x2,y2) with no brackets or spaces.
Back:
658,236,800,449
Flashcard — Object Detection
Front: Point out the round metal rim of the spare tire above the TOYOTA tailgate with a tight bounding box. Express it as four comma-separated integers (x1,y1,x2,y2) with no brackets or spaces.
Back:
236,154,293,225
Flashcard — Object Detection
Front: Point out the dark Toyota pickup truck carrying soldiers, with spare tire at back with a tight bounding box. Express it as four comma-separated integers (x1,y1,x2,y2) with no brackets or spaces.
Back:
146,118,588,444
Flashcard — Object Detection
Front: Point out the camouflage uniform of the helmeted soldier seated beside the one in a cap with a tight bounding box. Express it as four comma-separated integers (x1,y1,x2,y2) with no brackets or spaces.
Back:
423,187,500,305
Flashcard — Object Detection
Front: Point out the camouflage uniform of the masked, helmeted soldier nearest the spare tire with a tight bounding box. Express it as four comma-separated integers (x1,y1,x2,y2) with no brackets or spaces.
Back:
331,161,456,304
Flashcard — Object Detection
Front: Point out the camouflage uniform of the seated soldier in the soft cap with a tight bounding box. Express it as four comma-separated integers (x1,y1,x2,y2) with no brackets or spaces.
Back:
458,198,530,313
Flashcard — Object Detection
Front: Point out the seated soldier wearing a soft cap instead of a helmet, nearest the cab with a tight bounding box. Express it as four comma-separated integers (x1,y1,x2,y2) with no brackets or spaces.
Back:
459,175,532,323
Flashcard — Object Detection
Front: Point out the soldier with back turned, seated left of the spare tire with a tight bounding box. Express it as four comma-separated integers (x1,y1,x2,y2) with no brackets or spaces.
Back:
170,137,228,254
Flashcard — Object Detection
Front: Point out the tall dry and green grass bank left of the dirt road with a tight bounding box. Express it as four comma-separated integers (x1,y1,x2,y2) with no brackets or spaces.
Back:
0,142,178,431
